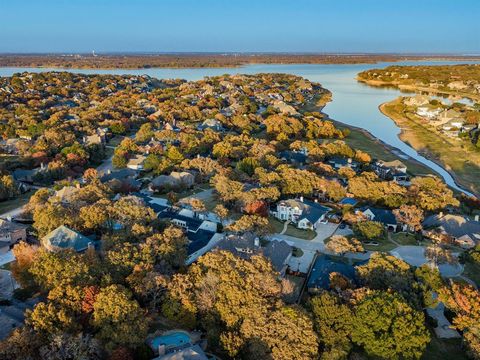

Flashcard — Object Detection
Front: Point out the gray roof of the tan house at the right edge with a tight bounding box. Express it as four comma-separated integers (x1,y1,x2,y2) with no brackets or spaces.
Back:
423,214,480,240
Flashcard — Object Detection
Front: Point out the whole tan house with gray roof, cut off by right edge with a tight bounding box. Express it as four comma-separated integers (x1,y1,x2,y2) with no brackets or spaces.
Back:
422,213,480,248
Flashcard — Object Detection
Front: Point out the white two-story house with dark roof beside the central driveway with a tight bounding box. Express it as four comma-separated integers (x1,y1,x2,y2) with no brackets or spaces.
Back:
272,197,331,230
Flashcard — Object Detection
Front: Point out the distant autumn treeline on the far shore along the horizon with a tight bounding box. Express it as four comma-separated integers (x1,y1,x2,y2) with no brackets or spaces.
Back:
0,53,480,69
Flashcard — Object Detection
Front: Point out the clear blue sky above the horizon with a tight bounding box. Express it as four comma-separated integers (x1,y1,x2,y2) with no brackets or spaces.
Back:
0,0,480,54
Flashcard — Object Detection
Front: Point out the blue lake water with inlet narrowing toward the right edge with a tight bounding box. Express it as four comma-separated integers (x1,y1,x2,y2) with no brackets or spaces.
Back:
0,61,473,195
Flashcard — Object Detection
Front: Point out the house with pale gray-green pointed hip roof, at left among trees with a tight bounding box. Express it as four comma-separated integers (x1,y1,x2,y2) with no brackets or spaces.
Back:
42,225,94,252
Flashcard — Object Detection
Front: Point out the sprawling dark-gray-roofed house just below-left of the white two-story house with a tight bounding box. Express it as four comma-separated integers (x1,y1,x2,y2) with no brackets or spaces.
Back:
216,232,292,276
